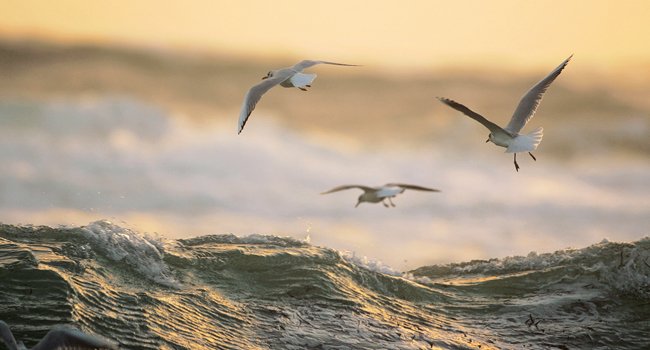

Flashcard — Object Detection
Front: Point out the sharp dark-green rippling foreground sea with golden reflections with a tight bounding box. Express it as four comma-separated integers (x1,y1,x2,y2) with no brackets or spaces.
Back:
0,221,650,349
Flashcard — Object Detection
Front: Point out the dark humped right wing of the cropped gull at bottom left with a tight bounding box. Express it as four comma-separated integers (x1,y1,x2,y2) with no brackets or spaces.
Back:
32,328,117,350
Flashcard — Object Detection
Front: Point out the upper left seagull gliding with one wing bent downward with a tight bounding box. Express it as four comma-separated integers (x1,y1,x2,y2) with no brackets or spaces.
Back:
237,60,358,134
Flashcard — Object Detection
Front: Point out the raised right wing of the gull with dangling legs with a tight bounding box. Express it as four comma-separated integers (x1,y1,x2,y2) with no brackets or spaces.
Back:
505,55,573,134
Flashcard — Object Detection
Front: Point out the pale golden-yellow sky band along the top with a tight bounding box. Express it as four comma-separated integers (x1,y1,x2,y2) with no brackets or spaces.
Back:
0,0,650,70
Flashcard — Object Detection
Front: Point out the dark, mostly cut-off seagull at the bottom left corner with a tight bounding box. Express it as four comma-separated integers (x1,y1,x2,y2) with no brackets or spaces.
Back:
0,321,117,350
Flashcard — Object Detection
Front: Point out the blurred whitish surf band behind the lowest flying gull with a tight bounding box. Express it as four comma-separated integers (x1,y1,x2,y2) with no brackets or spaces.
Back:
0,96,650,270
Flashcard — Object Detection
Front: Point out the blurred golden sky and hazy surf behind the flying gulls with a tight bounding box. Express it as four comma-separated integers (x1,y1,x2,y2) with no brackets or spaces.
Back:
0,0,650,270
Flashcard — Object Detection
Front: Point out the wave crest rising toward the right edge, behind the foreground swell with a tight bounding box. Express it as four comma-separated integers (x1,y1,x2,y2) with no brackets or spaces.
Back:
410,237,650,298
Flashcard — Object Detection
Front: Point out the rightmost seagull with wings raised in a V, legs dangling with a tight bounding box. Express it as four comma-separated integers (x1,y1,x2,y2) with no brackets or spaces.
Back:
438,55,573,171
